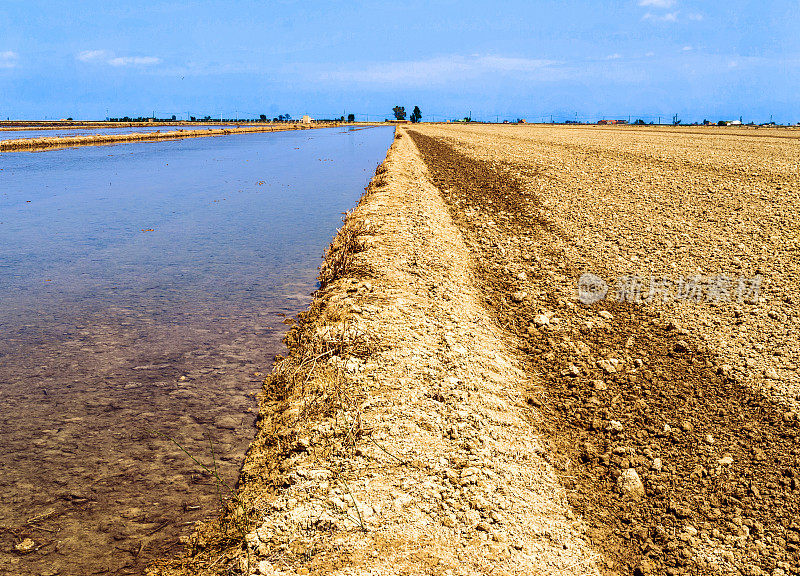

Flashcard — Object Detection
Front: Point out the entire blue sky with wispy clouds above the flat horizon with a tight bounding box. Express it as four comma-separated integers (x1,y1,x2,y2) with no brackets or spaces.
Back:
0,0,800,122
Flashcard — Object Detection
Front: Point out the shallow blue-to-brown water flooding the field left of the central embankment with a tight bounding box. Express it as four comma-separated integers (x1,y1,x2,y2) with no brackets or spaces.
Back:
0,128,393,575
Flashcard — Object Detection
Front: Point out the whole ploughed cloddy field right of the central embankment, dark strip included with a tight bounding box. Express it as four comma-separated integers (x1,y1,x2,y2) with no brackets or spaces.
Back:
412,127,800,574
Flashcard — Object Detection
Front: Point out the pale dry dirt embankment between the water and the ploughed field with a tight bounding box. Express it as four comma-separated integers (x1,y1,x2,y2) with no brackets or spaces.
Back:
154,133,596,575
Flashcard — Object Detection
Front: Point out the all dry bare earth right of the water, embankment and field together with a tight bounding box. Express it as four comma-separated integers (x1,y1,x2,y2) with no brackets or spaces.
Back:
152,125,800,576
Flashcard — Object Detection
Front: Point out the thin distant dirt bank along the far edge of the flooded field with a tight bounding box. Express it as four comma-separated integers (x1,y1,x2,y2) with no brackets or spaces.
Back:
0,124,339,152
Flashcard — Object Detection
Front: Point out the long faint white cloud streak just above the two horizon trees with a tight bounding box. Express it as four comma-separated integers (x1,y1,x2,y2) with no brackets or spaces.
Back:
316,54,557,85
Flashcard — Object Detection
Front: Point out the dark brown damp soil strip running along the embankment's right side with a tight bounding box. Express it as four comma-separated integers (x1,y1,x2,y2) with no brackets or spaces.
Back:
410,130,800,574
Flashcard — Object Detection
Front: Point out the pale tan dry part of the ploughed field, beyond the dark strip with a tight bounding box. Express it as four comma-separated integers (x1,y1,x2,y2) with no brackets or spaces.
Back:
410,126,800,407
